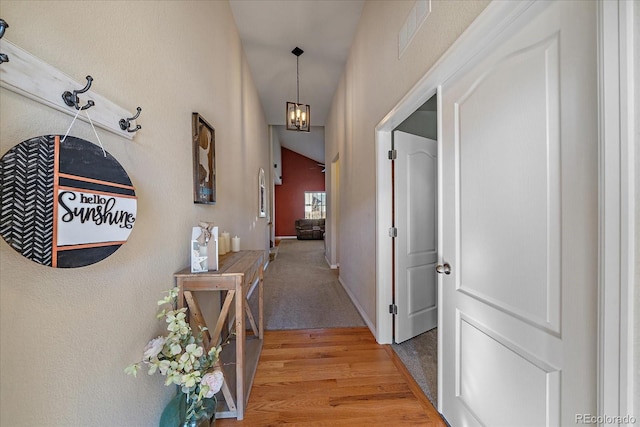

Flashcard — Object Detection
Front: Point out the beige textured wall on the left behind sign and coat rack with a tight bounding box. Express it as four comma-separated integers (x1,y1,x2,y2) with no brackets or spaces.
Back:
0,0,270,426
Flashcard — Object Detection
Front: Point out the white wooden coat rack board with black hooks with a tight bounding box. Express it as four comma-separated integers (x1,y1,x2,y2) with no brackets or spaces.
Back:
0,39,139,140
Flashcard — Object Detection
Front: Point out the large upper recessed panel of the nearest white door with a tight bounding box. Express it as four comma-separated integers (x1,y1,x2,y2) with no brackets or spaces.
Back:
460,33,560,333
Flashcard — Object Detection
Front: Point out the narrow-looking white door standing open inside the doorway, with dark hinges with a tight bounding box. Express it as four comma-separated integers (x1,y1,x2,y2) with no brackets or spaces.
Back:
393,131,438,343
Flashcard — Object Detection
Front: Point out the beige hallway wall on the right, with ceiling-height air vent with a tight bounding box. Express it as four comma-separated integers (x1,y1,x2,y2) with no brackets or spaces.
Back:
325,0,489,325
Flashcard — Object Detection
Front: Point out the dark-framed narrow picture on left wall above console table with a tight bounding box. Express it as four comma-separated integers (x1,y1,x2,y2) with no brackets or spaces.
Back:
192,113,216,205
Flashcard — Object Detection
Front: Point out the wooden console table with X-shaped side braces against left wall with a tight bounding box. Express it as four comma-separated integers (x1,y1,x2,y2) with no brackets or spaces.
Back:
174,251,265,420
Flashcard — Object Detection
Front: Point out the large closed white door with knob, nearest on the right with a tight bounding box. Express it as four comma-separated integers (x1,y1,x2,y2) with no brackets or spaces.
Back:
438,1,598,427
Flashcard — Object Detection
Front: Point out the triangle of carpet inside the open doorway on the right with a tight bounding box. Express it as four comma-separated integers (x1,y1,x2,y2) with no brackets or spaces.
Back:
391,328,438,408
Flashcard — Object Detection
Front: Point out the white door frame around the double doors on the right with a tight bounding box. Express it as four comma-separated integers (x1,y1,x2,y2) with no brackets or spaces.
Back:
375,0,640,415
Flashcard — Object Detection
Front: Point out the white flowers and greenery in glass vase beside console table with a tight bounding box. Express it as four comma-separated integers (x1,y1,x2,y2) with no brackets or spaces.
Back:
124,288,224,423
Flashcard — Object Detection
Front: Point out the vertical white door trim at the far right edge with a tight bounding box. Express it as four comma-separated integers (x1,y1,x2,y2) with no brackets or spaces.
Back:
598,0,637,422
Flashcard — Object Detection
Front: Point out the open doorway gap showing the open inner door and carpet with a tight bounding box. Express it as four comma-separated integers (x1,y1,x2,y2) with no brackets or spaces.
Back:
391,94,438,407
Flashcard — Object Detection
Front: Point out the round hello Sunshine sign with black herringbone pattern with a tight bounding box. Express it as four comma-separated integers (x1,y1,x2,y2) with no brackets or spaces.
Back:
0,135,137,268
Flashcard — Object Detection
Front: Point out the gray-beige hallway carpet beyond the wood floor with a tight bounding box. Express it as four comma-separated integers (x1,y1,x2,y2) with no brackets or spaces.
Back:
249,239,365,330
